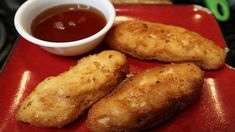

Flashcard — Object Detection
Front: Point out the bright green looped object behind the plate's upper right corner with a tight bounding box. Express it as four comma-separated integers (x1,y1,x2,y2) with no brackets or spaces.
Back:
205,0,230,21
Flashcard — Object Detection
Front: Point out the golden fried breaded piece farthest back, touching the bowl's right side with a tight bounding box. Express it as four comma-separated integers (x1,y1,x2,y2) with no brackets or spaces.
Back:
106,20,225,69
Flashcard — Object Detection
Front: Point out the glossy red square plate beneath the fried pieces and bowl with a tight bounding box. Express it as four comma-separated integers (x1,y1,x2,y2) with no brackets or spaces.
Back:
0,5,235,132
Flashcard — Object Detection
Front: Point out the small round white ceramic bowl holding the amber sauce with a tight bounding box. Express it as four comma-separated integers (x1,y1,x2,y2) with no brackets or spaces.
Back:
14,0,116,56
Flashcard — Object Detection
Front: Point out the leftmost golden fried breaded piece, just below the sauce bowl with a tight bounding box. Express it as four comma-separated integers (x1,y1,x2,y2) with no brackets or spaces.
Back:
16,50,128,127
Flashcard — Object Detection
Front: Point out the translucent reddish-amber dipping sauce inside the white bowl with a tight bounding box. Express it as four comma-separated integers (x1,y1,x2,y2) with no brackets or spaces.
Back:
31,4,106,42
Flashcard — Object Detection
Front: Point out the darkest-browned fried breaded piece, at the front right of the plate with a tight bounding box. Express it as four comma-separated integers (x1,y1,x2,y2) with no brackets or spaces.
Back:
87,63,203,132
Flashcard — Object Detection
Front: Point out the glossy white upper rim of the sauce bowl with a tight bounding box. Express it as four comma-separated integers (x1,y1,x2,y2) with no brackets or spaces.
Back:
14,0,116,48
